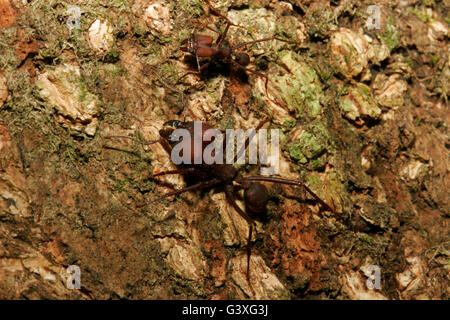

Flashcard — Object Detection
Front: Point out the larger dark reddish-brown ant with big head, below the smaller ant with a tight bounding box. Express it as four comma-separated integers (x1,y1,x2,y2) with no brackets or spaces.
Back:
109,120,334,283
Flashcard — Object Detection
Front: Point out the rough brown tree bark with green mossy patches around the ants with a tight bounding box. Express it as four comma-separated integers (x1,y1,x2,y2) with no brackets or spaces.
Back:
0,0,450,299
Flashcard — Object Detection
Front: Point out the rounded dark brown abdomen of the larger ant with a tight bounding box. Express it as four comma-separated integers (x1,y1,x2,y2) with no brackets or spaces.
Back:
243,182,269,220
